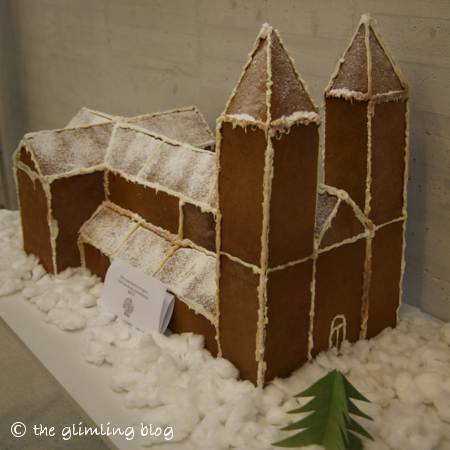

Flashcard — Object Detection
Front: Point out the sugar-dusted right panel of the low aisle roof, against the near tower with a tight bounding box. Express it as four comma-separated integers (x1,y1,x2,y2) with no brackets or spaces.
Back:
155,248,216,314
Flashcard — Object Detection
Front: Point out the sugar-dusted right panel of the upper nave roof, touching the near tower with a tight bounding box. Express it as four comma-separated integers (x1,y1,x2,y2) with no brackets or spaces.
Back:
142,144,216,202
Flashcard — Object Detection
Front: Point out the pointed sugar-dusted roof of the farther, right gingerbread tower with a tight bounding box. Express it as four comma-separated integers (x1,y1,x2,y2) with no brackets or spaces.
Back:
325,14,408,100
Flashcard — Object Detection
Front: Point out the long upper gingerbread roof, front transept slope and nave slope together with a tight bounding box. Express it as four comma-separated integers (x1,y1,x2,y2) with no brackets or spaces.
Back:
19,122,216,210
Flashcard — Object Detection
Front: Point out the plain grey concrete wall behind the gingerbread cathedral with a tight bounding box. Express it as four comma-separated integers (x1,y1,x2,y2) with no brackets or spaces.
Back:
0,0,450,321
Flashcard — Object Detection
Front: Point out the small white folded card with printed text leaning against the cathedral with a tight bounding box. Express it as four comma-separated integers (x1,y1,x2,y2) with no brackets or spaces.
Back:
100,258,175,333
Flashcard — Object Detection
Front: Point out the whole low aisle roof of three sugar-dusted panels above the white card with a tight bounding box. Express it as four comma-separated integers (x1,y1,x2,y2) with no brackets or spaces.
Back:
79,202,217,322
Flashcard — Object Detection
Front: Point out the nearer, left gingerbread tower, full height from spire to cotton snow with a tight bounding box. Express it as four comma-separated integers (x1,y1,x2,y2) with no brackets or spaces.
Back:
217,25,320,385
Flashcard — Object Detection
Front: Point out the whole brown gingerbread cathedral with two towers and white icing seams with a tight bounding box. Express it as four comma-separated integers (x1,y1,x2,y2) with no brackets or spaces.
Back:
14,15,409,386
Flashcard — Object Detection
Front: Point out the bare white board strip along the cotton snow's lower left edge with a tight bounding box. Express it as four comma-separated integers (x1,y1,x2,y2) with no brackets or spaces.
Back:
0,294,142,450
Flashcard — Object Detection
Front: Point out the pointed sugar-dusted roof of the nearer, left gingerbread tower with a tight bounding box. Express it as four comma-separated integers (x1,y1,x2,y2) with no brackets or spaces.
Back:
223,24,320,127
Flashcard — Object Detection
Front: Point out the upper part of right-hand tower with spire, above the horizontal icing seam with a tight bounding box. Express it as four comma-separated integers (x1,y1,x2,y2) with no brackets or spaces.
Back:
324,14,409,224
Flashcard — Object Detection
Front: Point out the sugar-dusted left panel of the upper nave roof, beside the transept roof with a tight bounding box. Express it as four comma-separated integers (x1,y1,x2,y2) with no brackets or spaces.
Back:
107,128,161,176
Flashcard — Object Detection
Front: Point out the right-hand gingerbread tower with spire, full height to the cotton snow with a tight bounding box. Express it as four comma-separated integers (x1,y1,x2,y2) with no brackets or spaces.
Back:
324,14,409,337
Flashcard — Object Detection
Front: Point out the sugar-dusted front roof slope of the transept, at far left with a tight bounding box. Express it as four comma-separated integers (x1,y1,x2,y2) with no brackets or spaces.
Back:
27,124,113,176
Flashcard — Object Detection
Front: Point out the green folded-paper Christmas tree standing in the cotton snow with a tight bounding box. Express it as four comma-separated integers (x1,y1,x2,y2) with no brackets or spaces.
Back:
272,370,373,450
